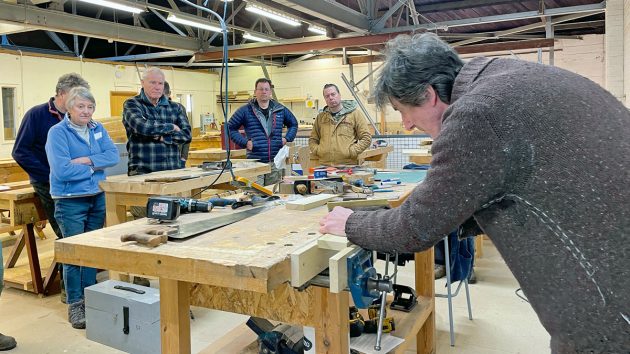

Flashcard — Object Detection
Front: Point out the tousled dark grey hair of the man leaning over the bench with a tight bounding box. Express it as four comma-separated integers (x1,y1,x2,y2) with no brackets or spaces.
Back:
374,33,464,107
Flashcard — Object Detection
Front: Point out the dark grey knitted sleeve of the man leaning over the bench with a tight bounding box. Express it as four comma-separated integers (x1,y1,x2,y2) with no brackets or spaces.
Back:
346,102,507,252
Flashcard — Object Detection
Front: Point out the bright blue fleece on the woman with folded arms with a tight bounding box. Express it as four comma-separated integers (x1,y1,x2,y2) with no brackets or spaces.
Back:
46,114,120,198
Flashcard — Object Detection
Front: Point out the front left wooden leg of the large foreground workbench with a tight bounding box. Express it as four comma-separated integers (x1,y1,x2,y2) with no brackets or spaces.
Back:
160,278,190,354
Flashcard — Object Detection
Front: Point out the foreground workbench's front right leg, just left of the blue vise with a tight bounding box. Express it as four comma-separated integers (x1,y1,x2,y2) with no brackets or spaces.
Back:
312,287,350,354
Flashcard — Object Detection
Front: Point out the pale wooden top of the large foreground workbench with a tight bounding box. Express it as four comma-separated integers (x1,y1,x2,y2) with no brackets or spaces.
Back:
55,205,326,293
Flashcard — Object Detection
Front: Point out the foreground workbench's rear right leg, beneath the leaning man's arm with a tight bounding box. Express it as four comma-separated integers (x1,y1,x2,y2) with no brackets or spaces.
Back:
414,247,437,354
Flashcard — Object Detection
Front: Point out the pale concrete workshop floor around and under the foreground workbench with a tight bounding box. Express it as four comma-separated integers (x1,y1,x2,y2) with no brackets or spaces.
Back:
0,233,550,354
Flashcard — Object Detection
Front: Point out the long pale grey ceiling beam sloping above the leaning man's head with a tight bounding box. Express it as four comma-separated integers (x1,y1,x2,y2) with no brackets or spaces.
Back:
375,1,606,33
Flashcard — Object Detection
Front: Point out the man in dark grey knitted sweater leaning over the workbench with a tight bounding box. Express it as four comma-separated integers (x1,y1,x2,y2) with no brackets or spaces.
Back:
320,34,630,353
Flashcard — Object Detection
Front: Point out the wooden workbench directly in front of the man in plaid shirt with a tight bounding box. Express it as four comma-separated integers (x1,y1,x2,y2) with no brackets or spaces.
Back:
100,162,270,226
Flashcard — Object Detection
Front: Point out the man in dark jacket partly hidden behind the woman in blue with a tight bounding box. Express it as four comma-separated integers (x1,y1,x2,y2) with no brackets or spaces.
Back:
12,73,90,238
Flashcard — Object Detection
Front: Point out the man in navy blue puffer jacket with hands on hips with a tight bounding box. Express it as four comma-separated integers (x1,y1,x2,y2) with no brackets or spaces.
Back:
228,78,298,186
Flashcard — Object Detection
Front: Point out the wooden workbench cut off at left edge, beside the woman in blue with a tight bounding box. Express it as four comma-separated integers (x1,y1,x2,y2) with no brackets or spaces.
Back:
0,181,58,294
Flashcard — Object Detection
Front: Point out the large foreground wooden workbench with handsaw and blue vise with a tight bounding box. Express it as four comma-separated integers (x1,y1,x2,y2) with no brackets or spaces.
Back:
55,174,435,354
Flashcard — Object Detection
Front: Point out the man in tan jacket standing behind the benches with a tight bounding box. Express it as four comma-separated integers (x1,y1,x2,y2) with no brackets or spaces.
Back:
308,84,372,166
